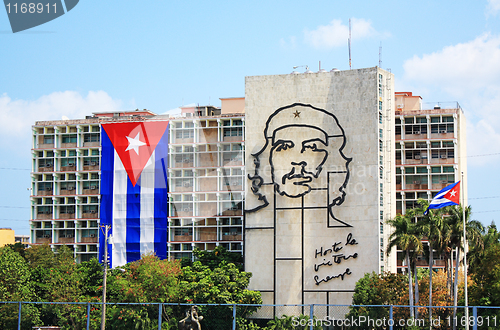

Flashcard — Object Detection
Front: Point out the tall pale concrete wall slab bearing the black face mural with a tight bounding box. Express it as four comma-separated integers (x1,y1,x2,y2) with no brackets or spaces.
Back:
245,68,396,312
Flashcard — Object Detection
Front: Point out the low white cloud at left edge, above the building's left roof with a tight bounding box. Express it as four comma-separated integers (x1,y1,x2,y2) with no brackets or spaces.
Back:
0,91,121,149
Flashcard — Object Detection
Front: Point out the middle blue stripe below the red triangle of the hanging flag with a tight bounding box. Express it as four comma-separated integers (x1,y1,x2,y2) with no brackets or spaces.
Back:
127,178,141,262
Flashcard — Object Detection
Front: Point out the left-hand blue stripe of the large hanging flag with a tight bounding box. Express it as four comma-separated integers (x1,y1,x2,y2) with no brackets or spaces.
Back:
99,128,115,265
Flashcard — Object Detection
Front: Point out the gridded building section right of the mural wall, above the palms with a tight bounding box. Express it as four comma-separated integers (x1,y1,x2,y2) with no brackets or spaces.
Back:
395,92,467,268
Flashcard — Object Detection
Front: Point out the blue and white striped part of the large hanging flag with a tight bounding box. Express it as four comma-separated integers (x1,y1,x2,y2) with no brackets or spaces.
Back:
99,122,169,267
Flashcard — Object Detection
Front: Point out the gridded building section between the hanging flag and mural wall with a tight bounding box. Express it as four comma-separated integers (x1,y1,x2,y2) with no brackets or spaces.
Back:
168,98,245,259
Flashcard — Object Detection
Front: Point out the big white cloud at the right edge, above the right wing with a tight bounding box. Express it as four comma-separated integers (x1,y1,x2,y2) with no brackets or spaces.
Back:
403,34,500,166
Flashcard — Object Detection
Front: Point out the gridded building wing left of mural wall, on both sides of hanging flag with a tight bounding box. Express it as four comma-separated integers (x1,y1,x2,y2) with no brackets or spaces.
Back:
31,98,244,262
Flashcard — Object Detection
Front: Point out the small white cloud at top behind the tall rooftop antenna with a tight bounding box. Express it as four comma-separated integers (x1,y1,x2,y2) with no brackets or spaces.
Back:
304,18,388,49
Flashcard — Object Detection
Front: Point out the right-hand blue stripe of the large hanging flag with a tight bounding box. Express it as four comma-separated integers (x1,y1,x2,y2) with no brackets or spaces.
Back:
154,127,168,259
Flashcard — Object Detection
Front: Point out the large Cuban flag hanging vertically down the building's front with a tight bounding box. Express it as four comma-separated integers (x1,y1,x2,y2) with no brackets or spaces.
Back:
99,121,168,267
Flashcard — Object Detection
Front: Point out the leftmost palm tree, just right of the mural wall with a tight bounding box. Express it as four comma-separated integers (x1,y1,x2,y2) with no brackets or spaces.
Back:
386,209,422,318
